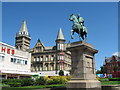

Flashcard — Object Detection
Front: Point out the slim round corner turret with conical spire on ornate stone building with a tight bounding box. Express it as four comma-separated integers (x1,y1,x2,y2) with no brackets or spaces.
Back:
56,28,65,70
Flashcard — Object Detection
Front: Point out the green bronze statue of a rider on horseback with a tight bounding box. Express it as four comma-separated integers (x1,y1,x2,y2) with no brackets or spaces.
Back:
69,14,87,41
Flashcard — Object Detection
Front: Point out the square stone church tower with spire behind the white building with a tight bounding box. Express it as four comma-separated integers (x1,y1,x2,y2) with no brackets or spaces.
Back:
15,20,31,51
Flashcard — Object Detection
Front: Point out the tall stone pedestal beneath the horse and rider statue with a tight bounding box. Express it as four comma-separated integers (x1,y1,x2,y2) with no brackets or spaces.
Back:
67,41,101,90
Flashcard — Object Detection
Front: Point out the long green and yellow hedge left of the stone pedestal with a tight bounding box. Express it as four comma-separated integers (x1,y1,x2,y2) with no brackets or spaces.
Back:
2,76,71,87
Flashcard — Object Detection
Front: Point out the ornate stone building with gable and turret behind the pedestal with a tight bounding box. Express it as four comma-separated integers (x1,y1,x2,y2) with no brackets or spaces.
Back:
31,28,71,76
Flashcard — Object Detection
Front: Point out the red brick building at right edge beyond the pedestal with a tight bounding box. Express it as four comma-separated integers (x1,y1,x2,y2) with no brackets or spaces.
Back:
103,55,120,74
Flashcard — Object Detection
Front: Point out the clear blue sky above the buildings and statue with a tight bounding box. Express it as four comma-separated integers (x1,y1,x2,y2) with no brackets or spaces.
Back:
2,2,118,70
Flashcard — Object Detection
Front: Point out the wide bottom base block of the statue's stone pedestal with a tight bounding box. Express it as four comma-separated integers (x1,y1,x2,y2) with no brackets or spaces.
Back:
67,80,101,90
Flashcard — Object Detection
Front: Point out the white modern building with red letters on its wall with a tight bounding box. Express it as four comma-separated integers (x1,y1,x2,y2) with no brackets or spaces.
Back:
0,42,31,79
